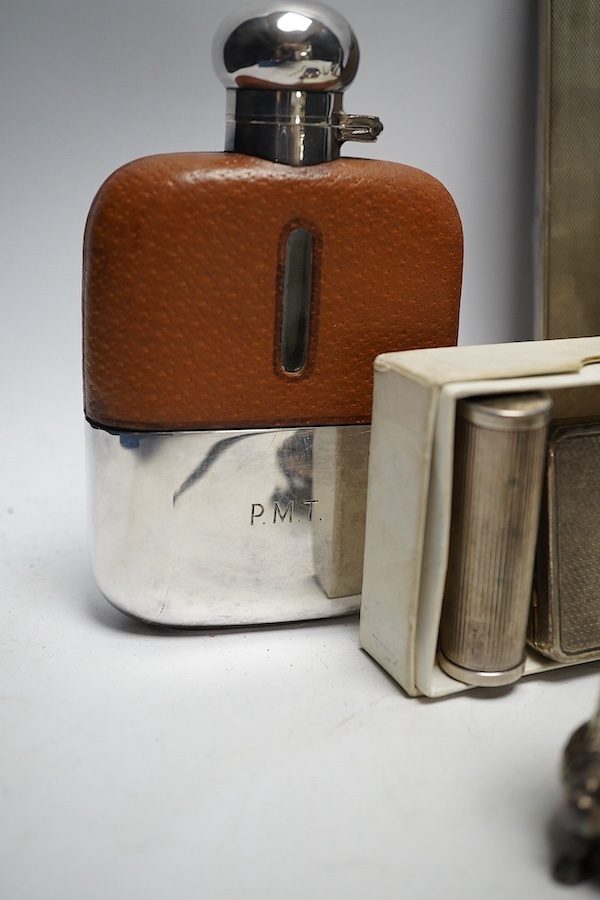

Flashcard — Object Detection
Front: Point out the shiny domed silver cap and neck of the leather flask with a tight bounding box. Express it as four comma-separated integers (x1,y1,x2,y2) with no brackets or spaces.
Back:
213,3,383,166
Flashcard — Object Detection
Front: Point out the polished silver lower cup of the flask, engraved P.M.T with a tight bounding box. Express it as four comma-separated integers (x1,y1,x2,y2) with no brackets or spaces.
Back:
87,425,370,627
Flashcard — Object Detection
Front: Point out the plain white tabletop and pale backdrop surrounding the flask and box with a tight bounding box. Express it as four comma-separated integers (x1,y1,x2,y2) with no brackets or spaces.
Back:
0,0,600,900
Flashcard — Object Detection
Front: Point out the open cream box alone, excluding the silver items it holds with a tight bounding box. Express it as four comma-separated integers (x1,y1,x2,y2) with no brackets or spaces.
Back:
360,337,600,697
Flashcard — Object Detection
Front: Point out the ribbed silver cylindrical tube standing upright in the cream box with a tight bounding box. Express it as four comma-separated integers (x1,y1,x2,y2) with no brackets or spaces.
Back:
439,393,552,686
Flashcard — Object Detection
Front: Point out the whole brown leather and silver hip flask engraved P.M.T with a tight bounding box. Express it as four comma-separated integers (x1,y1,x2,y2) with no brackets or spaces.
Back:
83,3,462,626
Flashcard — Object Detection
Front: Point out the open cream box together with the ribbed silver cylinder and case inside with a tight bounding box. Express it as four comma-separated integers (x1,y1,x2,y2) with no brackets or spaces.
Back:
360,337,600,697
